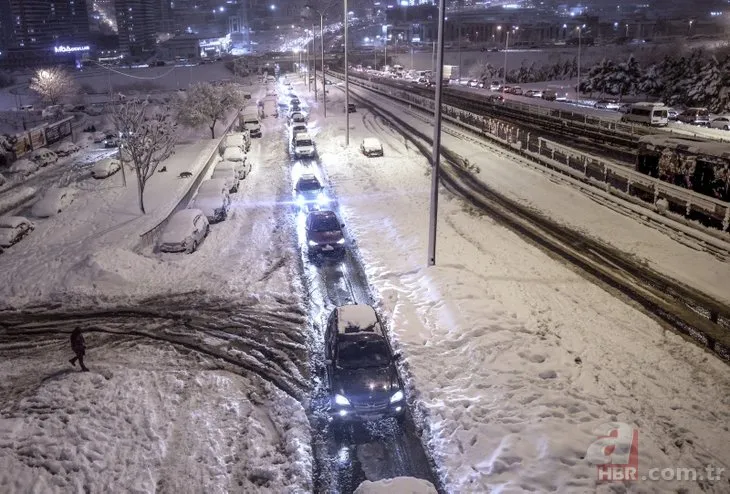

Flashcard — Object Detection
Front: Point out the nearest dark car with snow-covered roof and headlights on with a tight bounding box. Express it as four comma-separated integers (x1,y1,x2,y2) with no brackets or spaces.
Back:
324,304,406,424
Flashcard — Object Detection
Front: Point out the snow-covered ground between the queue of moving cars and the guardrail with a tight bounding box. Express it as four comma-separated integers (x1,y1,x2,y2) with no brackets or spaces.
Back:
315,87,730,494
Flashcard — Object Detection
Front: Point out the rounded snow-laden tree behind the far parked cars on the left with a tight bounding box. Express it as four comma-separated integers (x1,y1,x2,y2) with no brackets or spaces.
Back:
177,82,245,139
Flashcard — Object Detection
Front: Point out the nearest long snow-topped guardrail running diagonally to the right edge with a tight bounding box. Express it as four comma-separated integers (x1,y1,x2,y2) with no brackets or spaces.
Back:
332,72,730,236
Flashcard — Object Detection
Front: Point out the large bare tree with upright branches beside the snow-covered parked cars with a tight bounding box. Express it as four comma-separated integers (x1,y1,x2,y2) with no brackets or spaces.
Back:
112,100,177,214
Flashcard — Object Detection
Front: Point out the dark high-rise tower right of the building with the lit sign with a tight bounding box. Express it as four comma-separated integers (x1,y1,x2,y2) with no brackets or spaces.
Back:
116,0,162,56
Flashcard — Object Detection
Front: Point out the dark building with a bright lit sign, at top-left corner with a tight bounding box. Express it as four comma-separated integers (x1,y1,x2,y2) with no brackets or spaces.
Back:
0,0,91,67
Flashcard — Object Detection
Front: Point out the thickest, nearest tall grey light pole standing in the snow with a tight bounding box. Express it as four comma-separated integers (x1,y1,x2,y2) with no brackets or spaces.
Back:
424,0,446,266
